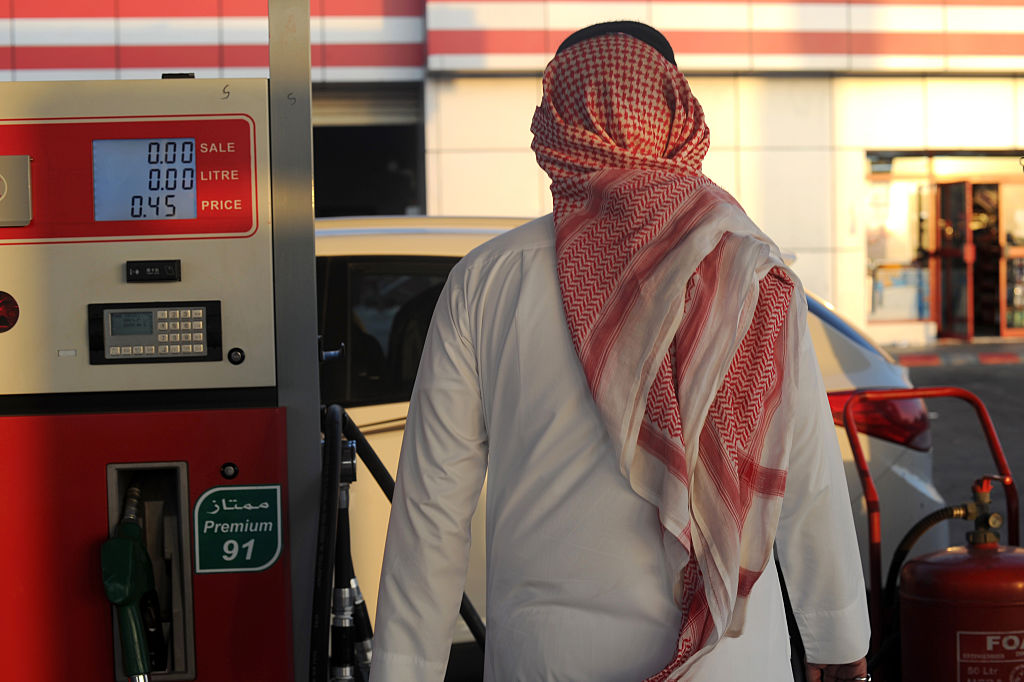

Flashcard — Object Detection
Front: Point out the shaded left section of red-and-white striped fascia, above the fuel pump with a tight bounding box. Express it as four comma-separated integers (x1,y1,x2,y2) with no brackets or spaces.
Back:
0,0,426,82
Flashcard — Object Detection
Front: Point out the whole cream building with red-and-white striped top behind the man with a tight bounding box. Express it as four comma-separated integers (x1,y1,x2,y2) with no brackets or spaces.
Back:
0,0,1024,343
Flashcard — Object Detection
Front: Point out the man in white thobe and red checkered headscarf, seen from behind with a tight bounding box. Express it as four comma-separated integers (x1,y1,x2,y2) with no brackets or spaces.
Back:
372,23,869,682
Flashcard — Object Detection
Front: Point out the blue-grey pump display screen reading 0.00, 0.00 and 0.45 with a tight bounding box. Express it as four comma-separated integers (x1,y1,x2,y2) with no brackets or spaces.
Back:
92,137,196,222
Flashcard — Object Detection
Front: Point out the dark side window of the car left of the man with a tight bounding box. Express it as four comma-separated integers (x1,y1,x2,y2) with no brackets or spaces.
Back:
316,256,458,406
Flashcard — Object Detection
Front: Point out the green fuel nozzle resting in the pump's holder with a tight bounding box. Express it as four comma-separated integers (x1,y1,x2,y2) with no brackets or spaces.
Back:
99,486,154,682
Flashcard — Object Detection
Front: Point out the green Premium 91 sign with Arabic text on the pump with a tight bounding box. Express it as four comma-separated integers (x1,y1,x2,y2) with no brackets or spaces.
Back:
194,485,282,573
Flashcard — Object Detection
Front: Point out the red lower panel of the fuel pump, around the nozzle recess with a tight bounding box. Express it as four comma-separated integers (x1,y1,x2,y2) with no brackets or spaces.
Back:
0,408,294,682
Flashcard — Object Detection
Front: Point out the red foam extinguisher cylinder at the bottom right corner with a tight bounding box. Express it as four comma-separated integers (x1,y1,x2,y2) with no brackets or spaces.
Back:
899,543,1024,682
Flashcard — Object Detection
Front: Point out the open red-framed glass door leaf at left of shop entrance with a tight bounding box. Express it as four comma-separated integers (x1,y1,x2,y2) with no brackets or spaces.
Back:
935,182,975,339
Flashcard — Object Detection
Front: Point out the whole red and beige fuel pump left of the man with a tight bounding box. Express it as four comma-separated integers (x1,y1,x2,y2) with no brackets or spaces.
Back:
0,45,318,682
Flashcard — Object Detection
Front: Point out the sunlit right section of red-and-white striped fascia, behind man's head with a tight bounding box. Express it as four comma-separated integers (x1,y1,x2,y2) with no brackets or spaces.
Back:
427,0,1024,73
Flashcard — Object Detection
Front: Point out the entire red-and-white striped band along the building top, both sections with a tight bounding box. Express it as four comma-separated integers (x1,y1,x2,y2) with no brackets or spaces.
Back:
0,0,1024,82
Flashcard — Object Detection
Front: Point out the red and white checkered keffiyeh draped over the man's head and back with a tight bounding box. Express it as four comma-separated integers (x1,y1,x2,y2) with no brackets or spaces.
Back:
532,33,805,681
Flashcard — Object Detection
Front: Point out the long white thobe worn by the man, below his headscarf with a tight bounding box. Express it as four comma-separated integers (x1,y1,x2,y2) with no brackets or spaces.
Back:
371,216,868,682
